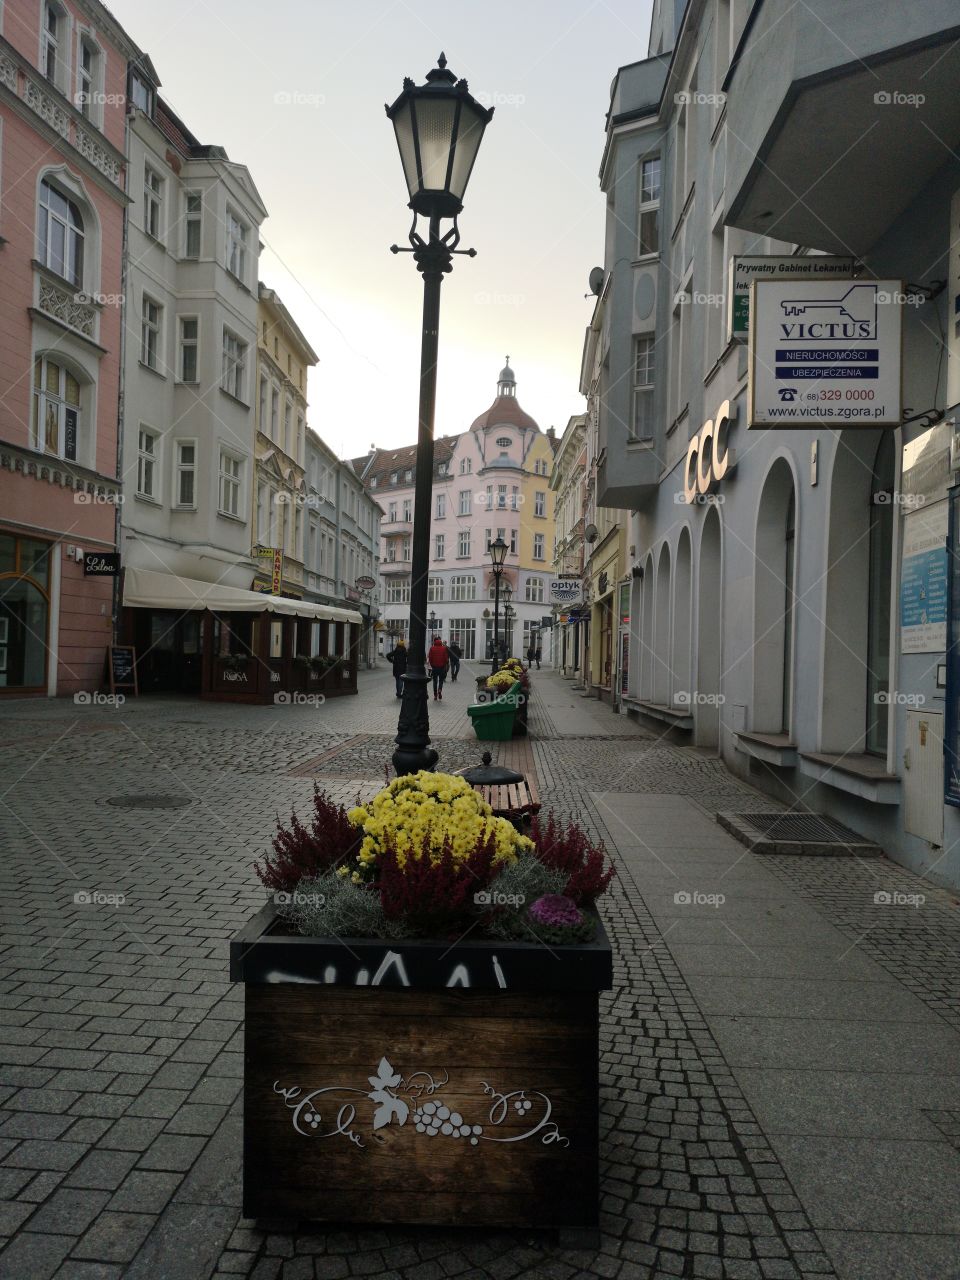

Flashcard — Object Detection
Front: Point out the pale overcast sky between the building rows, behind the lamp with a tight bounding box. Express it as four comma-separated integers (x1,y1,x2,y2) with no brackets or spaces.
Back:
110,0,650,456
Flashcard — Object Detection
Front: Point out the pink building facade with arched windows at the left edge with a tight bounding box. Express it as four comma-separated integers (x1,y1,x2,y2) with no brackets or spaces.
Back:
0,0,141,696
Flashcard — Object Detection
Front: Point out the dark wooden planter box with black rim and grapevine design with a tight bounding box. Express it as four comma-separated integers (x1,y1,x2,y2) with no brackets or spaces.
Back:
230,904,612,1231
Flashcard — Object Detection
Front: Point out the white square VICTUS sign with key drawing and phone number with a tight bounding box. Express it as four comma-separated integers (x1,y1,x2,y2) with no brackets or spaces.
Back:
748,279,905,428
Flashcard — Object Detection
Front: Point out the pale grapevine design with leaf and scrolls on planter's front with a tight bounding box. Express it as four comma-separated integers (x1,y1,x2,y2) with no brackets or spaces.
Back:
274,1057,570,1147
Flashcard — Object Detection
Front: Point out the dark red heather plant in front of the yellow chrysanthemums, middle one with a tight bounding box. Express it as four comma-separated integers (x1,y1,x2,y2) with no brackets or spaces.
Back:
378,838,497,938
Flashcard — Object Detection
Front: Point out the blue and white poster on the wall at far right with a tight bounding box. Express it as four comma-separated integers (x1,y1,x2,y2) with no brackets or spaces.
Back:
900,502,948,653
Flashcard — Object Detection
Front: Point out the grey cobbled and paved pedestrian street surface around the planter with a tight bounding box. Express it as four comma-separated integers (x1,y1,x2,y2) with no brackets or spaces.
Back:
0,663,960,1280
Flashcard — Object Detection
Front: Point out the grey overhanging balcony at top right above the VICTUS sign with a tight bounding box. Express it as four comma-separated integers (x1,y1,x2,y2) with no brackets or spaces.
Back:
723,0,960,256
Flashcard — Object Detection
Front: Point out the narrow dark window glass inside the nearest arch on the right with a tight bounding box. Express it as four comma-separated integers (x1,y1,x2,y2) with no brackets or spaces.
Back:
867,431,896,755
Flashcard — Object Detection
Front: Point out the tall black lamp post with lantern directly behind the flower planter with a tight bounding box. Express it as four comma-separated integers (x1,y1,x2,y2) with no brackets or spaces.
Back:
387,54,493,774
